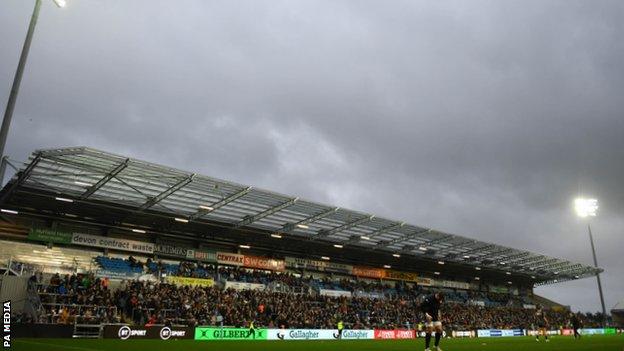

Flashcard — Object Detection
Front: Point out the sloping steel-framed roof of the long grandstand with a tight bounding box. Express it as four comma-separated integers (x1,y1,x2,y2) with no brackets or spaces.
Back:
0,147,600,285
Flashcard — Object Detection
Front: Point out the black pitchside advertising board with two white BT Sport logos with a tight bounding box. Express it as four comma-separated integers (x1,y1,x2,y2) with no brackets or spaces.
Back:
104,325,193,340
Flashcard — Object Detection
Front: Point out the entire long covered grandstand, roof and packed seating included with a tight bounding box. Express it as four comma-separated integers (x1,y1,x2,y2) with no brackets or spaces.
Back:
0,147,616,340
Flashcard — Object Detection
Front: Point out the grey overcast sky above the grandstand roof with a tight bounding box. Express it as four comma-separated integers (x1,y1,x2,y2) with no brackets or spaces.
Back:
0,0,624,311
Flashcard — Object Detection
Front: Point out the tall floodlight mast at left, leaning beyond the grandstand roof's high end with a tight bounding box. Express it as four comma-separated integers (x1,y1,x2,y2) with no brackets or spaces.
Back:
0,0,67,187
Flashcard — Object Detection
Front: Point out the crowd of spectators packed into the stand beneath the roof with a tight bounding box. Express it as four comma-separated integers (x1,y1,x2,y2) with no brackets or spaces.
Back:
31,269,601,330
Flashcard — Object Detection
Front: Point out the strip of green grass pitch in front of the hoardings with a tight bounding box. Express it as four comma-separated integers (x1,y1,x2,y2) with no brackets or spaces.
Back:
11,335,624,351
